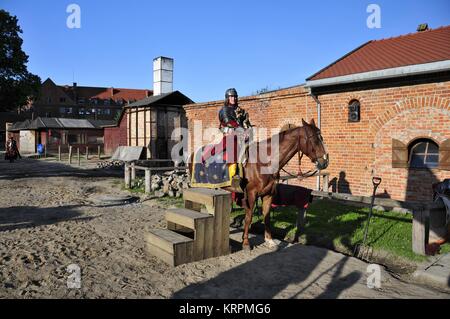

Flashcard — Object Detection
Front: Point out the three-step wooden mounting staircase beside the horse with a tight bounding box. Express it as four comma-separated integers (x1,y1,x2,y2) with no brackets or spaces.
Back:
145,188,232,266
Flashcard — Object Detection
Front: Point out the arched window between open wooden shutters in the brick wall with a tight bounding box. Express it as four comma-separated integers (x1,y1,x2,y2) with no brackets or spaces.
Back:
408,139,439,168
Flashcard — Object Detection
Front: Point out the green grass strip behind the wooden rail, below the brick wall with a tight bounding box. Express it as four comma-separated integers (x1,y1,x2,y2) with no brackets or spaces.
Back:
232,199,450,262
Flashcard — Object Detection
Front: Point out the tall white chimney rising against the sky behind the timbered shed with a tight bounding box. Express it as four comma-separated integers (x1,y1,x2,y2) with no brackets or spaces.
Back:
153,56,173,96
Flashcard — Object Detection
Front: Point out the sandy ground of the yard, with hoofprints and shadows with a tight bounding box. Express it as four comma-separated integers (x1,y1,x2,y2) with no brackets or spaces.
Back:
0,160,450,298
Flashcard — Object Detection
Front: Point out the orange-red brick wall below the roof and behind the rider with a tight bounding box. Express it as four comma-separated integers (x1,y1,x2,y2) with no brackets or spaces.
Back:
185,82,450,201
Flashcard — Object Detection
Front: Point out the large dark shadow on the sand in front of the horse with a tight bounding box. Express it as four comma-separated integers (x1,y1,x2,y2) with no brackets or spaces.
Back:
172,245,362,299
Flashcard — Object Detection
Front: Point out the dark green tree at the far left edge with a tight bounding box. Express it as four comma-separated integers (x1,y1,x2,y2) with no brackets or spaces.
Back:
0,10,41,111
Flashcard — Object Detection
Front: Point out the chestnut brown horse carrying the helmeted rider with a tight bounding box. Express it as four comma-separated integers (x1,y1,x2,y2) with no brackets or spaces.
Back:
188,119,329,250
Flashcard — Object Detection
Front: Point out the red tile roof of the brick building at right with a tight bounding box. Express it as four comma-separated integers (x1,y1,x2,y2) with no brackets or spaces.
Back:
307,26,450,81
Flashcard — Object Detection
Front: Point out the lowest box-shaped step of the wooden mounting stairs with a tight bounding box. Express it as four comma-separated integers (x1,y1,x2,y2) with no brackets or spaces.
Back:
144,229,194,266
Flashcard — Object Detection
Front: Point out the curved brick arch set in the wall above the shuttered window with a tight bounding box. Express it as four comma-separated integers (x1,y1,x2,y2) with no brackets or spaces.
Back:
370,95,450,136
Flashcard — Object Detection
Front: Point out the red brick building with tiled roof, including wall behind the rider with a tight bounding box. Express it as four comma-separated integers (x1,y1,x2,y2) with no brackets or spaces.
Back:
185,26,450,201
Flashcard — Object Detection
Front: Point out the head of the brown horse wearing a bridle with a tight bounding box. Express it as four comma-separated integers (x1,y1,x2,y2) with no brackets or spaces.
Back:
300,119,328,170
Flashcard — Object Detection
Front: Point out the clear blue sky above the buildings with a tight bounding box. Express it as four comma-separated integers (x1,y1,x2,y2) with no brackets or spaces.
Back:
0,0,450,102
